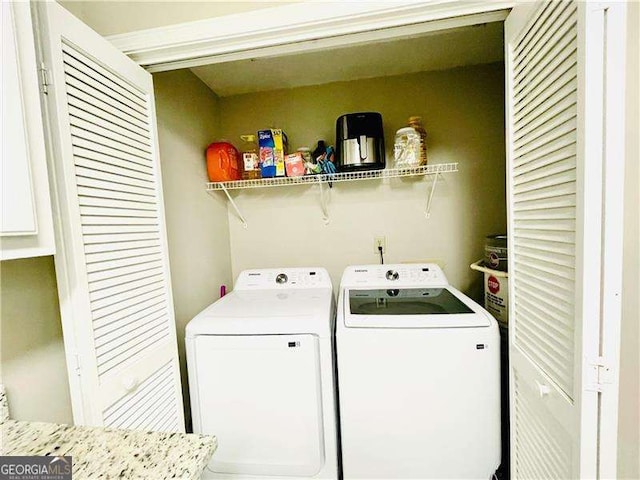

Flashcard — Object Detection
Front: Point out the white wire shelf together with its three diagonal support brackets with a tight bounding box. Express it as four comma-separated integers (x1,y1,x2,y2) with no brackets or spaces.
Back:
206,162,458,228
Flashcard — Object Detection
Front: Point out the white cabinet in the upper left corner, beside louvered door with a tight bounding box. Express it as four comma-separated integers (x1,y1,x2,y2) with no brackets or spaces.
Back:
0,2,55,260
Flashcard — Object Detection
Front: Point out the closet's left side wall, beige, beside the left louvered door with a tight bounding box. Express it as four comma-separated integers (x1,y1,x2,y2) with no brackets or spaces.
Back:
153,70,231,428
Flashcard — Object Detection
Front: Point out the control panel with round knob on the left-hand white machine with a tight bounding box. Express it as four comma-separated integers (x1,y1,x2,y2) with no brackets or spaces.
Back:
235,268,331,290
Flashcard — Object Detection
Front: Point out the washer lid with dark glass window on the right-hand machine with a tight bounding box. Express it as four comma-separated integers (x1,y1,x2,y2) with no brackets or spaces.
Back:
344,287,491,328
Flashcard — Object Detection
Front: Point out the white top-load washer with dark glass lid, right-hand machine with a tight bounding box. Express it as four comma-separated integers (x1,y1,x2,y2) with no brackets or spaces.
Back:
336,264,500,480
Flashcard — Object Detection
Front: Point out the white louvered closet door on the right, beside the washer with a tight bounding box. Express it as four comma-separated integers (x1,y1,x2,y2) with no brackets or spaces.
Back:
505,1,628,479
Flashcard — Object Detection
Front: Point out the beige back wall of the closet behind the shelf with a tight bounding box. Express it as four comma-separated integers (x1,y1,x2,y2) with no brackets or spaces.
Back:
218,64,506,294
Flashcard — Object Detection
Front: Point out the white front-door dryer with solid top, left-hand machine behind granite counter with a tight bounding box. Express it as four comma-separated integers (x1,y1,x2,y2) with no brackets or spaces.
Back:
186,268,338,479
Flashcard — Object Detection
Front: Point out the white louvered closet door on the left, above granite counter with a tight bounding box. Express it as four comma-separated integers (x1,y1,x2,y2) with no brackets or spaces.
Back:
38,2,184,431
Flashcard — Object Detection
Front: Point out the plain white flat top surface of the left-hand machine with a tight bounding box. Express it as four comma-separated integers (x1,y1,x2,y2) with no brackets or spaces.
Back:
186,288,334,337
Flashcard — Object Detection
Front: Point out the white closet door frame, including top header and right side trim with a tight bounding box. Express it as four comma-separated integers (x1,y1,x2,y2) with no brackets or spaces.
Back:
107,0,626,478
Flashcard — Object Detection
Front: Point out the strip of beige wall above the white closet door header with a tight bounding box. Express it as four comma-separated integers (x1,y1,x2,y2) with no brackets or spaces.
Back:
58,0,295,35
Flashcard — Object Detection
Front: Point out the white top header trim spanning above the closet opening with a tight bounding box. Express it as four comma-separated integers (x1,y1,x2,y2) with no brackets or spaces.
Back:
107,0,515,73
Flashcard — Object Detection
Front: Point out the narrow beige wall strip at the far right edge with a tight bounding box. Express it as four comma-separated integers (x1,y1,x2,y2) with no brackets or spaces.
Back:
618,2,640,479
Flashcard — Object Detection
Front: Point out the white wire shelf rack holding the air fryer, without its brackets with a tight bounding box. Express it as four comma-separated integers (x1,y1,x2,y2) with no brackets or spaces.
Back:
207,162,458,192
